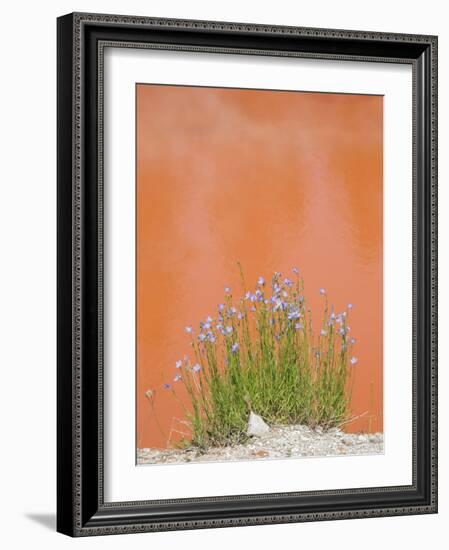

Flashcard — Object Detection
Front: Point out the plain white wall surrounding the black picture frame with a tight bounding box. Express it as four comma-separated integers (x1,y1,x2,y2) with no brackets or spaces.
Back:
0,0,440,550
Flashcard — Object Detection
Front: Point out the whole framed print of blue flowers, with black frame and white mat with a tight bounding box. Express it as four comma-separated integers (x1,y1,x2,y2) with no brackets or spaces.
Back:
57,13,437,536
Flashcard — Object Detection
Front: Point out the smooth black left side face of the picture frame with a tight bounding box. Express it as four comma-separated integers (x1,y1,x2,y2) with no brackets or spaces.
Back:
56,15,75,535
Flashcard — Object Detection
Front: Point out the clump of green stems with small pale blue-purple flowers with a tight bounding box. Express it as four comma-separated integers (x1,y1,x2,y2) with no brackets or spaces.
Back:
165,268,357,448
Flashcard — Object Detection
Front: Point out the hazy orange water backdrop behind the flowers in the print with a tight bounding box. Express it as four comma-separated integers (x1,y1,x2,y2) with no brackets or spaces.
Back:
136,84,383,447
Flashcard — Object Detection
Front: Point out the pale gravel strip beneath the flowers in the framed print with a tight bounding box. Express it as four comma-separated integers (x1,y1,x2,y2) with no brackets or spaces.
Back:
137,426,384,465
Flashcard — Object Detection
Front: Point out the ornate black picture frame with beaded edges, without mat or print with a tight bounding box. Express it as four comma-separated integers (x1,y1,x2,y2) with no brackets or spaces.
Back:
57,13,437,536
